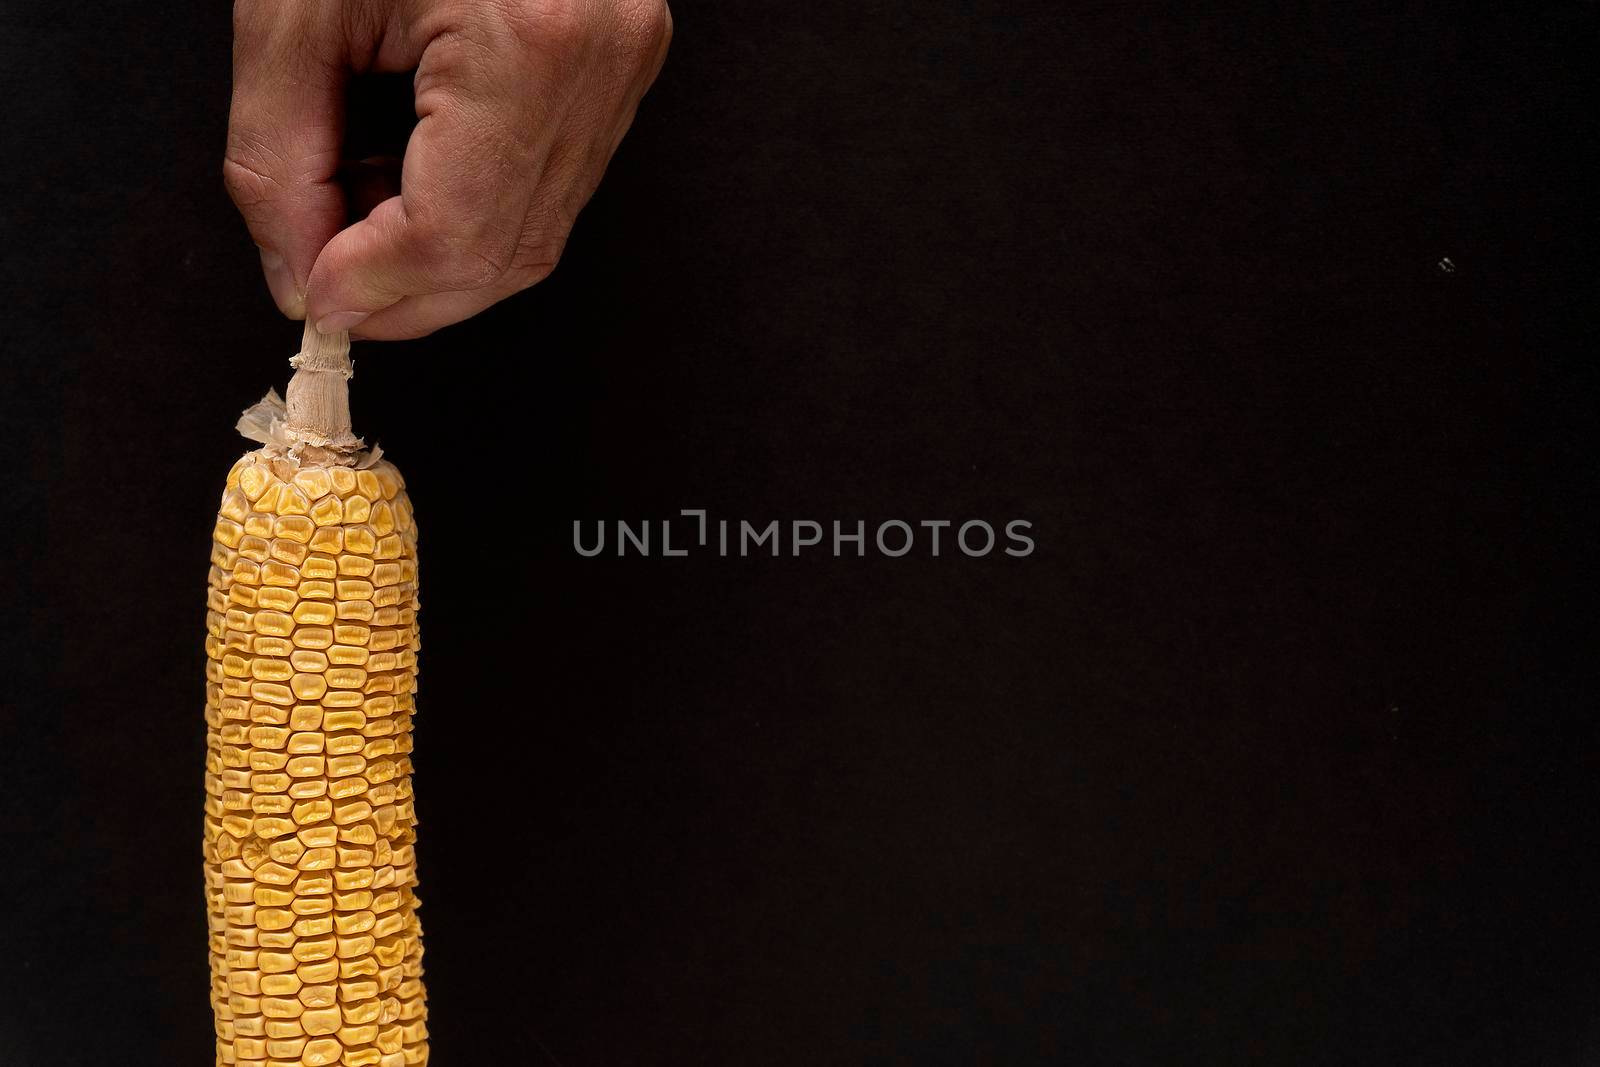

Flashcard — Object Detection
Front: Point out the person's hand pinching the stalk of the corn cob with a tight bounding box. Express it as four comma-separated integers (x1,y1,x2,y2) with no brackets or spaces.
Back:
222,0,672,339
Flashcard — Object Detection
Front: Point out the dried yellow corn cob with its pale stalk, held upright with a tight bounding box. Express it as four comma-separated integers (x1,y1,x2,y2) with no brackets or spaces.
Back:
205,328,429,1067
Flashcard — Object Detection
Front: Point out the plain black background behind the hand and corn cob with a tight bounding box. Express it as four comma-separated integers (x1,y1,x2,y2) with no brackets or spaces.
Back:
0,0,1600,1067
